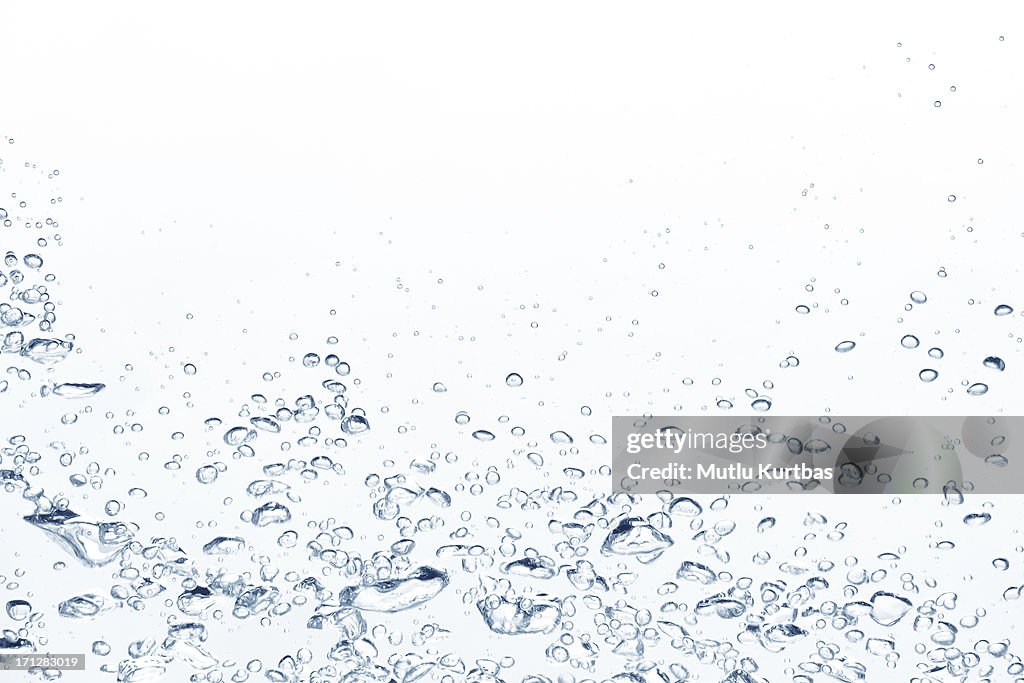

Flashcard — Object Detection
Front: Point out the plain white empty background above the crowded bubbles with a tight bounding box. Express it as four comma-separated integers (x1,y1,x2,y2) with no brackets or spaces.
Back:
0,3,1021,413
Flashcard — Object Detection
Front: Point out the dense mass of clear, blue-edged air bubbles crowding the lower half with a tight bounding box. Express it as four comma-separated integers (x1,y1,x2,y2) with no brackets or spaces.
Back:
0,125,1024,683
